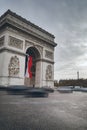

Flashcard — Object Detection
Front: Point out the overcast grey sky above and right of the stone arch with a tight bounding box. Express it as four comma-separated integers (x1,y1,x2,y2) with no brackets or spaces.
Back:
0,0,87,80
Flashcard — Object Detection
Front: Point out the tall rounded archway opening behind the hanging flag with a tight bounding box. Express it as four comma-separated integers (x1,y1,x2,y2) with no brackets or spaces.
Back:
24,47,40,87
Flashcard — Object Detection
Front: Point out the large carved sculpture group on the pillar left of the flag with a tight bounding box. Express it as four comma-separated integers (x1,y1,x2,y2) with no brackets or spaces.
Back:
8,56,20,76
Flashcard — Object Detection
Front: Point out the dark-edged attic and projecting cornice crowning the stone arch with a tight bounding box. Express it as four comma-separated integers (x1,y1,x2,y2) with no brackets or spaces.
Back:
0,10,57,47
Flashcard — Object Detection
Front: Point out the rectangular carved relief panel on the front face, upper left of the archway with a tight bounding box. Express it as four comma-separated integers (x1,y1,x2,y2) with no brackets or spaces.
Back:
9,36,23,49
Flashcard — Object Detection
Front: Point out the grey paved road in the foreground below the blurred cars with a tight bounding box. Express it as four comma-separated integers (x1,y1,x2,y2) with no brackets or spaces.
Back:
0,91,87,130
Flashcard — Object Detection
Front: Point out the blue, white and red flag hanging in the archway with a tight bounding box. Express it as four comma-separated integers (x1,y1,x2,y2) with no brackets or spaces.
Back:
25,56,32,78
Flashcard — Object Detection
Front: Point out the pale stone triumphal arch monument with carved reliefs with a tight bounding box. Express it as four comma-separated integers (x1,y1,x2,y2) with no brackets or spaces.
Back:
0,10,57,87
